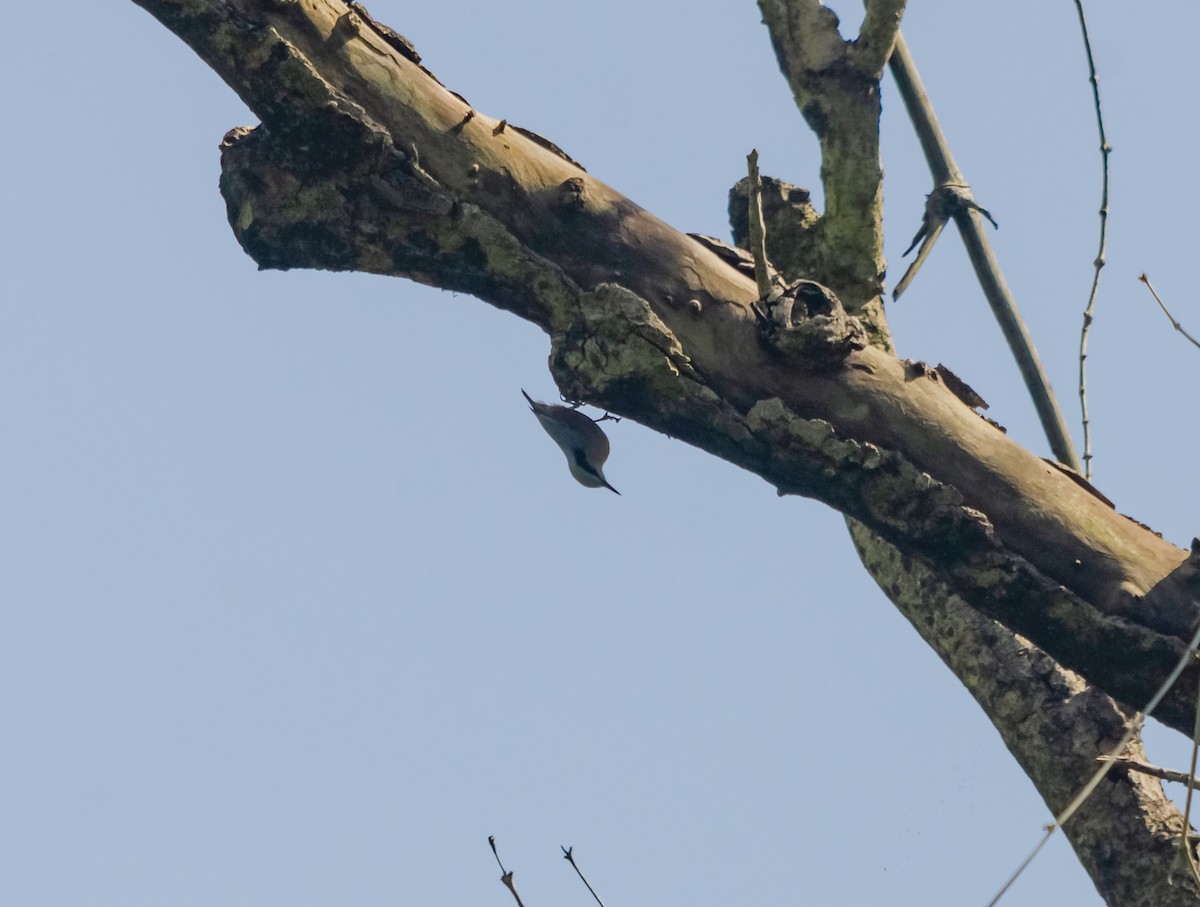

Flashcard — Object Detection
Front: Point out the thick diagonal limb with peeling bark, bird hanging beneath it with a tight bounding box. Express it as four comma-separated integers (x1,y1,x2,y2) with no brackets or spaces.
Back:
131,0,1198,728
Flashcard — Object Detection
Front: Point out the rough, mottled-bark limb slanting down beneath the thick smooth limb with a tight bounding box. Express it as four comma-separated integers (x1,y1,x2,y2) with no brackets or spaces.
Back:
851,524,1200,907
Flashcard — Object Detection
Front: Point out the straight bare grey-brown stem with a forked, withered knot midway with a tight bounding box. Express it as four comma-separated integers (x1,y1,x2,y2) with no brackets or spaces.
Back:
888,34,1080,471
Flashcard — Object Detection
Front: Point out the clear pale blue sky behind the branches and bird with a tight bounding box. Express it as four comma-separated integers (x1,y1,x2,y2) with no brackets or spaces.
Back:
0,0,1200,907
